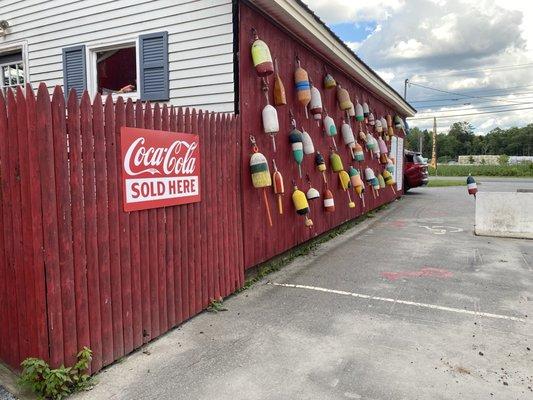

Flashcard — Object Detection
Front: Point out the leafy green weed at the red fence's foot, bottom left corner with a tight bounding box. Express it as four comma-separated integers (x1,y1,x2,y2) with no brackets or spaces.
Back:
19,347,93,400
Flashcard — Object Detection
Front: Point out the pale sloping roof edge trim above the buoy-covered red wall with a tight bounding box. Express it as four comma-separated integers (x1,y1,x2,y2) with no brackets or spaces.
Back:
248,0,416,117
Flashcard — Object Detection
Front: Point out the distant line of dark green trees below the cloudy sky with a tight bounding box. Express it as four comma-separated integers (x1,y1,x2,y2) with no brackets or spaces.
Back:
405,122,533,162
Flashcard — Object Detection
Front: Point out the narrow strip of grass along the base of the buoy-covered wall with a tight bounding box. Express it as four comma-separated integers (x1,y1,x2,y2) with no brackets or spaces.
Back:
235,204,388,294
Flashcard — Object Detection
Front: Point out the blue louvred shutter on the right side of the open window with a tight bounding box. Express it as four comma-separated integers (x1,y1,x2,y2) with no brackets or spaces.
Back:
139,32,170,101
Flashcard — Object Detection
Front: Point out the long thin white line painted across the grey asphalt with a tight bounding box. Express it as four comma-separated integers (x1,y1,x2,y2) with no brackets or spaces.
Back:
269,282,526,322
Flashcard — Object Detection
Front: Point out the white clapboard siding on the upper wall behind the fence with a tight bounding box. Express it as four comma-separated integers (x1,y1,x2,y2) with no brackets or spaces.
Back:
0,0,235,112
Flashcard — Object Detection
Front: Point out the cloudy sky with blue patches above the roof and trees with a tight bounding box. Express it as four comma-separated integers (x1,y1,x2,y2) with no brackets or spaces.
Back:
304,0,533,134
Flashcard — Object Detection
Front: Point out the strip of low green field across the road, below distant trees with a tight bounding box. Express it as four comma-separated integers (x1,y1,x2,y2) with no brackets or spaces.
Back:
429,163,533,177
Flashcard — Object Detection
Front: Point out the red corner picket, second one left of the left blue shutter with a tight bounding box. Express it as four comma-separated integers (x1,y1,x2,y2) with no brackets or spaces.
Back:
37,83,64,367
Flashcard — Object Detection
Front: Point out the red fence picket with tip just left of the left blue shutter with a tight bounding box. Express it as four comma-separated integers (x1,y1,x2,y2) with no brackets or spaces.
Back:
52,86,78,365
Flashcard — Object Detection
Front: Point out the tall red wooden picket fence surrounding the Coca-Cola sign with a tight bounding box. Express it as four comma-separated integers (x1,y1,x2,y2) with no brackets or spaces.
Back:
0,84,244,372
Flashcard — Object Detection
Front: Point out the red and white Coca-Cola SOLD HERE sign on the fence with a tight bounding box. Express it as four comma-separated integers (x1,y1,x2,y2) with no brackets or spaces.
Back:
120,127,200,211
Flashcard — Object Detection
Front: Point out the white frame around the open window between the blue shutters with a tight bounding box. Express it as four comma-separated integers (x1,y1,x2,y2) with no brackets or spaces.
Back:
85,36,141,102
